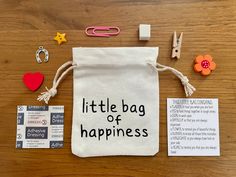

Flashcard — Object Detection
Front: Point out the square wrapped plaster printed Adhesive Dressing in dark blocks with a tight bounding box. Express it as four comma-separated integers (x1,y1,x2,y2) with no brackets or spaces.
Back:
16,105,64,148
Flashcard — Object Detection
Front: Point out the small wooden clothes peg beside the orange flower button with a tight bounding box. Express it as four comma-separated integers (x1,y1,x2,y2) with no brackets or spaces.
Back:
172,31,183,59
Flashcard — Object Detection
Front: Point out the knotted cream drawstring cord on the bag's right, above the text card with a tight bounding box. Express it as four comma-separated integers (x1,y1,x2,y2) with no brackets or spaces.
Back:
147,62,196,97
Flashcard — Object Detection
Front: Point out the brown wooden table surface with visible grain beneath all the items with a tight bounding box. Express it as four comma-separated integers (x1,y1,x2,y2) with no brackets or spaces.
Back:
0,0,236,177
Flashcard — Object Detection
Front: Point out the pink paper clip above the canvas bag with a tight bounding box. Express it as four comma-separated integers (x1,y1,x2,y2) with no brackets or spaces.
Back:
85,26,120,37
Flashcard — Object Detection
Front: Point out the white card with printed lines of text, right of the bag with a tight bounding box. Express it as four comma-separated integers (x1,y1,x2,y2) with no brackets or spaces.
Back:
167,98,220,156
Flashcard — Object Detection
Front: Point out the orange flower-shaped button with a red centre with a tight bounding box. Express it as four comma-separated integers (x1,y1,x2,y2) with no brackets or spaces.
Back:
194,55,216,76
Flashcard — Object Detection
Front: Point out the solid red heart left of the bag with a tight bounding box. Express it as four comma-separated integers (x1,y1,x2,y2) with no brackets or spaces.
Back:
23,72,44,91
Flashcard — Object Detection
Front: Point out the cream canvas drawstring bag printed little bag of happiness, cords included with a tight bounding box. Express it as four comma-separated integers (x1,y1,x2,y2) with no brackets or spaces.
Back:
38,47,195,157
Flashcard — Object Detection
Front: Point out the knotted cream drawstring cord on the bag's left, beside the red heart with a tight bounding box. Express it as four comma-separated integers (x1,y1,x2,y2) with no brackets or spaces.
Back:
37,61,77,104
